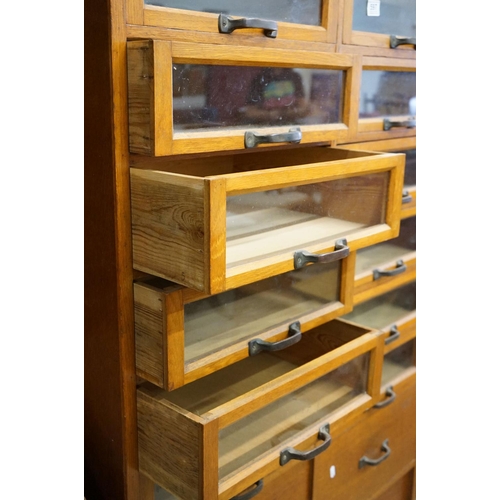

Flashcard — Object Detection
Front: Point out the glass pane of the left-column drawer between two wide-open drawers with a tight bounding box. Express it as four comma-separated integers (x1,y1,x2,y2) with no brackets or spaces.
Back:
184,261,341,363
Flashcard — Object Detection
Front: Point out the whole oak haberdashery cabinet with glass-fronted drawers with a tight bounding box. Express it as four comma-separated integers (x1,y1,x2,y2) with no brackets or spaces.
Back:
85,0,417,500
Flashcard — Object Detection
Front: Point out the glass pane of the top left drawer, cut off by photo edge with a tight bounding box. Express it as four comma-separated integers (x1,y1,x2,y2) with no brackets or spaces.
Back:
144,0,321,26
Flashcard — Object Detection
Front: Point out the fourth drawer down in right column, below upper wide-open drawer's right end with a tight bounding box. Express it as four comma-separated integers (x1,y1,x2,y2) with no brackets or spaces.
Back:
354,217,417,305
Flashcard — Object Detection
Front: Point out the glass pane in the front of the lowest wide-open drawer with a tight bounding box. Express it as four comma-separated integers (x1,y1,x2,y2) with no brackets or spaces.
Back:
219,354,368,478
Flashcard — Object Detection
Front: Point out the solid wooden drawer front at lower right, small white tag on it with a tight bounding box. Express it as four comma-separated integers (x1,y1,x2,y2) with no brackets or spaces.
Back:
312,378,416,500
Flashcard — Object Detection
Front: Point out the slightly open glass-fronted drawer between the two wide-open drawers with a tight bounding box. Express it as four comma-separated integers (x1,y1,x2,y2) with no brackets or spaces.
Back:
134,255,354,390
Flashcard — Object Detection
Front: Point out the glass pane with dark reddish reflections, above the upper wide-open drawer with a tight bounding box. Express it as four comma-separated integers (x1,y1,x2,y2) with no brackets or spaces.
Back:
173,64,344,131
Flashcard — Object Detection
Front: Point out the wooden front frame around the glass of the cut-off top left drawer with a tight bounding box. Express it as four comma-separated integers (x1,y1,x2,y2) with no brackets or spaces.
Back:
127,0,339,45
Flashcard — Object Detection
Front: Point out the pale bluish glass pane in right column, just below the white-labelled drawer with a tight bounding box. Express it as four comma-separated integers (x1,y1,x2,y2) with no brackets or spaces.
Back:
359,70,416,118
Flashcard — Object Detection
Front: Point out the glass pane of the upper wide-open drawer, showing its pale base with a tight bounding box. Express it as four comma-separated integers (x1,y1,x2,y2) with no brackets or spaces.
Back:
226,172,389,269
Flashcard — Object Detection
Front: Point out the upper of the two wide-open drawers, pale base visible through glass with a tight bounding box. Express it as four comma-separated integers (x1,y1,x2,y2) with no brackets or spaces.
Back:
131,147,404,294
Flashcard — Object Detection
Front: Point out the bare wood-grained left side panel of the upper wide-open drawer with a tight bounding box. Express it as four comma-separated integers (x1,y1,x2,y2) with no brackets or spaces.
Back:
130,169,205,290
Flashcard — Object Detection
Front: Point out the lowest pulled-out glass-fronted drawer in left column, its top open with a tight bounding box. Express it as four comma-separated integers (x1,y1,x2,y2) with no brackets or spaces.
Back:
137,321,383,500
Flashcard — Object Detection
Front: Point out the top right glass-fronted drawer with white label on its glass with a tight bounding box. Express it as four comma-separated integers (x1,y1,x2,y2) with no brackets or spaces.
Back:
342,0,417,58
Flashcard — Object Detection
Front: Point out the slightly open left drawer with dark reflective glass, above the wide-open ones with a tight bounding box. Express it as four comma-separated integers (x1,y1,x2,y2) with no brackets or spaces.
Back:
127,40,360,156
